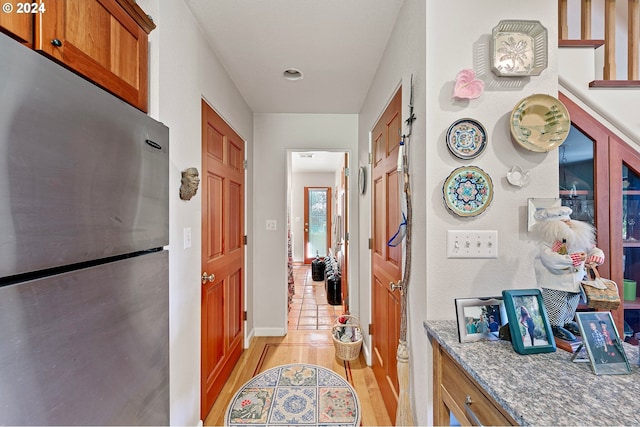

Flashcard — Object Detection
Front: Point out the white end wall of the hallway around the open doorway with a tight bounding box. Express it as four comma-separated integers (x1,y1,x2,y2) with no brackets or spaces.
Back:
251,114,358,336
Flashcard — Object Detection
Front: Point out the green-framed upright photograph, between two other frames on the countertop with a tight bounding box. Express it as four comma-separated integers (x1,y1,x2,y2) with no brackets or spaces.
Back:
502,289,556,354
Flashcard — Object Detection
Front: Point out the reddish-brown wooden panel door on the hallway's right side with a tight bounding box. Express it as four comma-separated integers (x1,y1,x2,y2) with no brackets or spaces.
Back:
371,89,402,419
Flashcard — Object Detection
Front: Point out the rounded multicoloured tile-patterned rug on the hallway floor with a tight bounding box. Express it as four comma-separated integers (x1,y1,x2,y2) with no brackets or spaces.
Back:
225,364,361,426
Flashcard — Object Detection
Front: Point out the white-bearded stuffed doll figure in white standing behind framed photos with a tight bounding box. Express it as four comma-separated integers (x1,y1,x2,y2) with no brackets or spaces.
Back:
531,206,604,341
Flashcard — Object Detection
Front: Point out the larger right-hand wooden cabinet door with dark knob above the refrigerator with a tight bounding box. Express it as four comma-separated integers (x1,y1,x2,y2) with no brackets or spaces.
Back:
34,0,148,112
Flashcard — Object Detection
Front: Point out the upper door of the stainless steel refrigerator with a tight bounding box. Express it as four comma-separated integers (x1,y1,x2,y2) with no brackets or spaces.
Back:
0,34,170,278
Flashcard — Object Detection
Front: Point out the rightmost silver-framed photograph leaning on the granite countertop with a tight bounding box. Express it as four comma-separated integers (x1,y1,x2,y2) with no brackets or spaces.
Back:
576,311,631,375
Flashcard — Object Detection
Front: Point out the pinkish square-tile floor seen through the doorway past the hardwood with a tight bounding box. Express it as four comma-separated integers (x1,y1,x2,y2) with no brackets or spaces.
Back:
289,265,343,330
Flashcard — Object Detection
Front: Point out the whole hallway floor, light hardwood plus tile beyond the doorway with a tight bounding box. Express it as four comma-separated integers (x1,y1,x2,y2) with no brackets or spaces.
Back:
204,267,395,426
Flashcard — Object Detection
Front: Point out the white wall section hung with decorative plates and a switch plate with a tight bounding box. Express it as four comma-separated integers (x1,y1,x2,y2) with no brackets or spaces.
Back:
428,0,558,426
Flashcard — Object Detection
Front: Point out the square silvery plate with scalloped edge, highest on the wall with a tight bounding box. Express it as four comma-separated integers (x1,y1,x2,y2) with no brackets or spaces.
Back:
491,20,547,77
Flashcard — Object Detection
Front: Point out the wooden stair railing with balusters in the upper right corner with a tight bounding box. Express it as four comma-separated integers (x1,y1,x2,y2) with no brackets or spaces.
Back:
558,0,640,87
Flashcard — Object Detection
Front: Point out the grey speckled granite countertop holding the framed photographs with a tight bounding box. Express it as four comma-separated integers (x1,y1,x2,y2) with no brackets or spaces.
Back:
424,320,640,426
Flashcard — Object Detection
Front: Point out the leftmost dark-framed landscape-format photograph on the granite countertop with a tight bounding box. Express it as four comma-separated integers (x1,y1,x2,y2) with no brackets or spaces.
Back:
455,297,507,343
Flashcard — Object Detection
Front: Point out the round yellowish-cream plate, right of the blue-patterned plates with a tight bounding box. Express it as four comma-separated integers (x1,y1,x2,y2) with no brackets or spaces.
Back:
509,94,571,153
